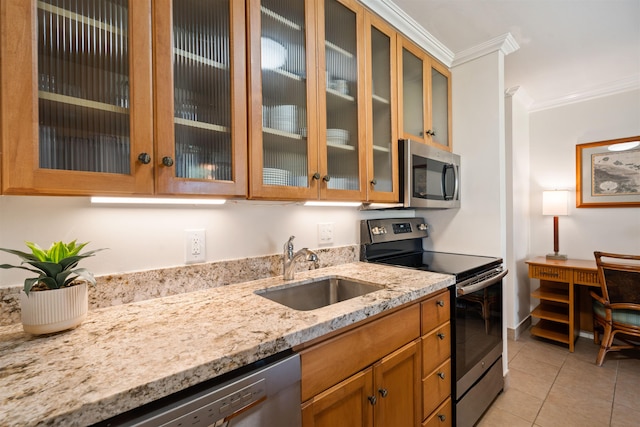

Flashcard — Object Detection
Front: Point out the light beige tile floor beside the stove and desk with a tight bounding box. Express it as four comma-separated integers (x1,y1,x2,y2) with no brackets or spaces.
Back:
478,332,640,427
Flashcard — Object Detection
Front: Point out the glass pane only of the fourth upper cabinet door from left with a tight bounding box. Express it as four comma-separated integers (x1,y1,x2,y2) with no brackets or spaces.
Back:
325,0,360,190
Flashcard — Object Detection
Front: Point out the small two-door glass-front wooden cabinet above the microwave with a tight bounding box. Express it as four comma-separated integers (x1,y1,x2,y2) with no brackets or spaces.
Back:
398,36,451,151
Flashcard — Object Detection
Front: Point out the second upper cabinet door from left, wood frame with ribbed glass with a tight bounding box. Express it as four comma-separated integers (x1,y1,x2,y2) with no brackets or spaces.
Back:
153,0,247,196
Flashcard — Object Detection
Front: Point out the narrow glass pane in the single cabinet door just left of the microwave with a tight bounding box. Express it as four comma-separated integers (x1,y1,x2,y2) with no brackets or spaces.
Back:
371,27,393,191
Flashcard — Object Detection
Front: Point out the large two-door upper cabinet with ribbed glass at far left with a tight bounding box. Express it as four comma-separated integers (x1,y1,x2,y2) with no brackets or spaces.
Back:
1,0,247,195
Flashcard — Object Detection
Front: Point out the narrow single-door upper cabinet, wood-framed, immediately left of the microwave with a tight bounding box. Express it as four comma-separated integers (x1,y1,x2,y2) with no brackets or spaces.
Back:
365,13,398,202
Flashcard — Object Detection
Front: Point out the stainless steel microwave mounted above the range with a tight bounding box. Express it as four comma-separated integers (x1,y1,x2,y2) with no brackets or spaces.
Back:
398,139,460,209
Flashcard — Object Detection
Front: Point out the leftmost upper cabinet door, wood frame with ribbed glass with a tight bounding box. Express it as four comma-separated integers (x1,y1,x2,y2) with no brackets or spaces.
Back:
0,0,153,195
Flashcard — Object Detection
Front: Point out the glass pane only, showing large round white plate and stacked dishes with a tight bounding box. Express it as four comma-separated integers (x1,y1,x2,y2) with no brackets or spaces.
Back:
261,0,309,187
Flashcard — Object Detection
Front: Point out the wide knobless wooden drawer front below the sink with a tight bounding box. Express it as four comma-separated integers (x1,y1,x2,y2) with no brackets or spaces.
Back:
300,304,420,402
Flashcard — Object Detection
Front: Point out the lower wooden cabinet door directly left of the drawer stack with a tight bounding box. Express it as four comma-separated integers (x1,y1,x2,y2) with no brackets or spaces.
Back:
373,341,421,427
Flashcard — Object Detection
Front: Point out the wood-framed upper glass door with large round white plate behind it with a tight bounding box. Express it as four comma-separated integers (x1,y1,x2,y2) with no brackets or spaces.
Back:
249,0,317,199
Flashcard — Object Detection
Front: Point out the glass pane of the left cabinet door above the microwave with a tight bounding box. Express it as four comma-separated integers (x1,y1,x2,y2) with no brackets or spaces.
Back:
402,49,425,136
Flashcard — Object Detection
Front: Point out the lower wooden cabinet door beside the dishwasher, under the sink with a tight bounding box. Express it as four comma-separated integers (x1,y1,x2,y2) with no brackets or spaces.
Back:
302,366,374,427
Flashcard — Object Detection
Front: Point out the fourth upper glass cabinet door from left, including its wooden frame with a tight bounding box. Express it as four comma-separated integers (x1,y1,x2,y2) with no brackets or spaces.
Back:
319,0,366,200
